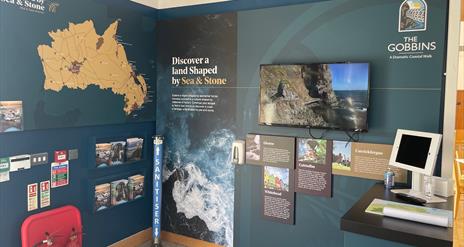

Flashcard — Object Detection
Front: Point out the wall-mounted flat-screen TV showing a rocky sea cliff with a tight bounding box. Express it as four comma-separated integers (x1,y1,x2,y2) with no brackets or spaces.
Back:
259,63,369,131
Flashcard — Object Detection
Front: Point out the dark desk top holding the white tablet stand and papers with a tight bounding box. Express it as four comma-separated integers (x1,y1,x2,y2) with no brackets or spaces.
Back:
340,184,453,247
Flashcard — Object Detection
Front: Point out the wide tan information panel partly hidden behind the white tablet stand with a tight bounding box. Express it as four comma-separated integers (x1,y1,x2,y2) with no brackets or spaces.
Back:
332,141,407,183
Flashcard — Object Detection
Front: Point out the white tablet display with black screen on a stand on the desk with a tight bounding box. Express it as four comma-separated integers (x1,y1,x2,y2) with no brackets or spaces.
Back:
389,129,442,202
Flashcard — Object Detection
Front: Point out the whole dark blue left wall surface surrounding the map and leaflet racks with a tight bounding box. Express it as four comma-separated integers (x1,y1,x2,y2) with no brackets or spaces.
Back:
0,0,157,247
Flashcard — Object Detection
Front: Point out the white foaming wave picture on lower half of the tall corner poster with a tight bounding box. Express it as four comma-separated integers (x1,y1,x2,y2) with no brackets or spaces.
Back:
163,120,235,246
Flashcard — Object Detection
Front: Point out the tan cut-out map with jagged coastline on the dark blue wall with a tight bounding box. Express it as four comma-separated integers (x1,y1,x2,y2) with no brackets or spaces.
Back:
37,20,147,115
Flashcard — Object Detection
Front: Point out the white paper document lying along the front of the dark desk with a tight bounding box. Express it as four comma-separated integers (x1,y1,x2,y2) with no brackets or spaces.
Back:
365,199,453,227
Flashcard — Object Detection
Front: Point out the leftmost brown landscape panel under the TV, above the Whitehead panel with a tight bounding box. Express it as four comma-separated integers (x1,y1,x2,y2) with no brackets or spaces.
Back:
245,134,295,169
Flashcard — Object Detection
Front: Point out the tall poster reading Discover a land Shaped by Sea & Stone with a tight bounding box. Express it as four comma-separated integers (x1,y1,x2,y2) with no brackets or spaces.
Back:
156,14,237,246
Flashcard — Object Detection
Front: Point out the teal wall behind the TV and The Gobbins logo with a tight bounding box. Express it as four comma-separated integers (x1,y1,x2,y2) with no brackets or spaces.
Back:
158,0,447,247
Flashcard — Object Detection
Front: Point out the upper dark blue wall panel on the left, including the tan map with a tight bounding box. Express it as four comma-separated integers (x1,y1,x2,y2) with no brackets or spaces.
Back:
0,0,156,130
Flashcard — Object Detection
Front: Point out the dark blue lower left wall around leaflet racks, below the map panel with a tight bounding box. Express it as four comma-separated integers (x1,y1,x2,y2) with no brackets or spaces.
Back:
0,122,155,247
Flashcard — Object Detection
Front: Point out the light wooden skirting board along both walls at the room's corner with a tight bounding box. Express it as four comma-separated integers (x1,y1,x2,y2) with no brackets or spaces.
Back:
109,228,222,247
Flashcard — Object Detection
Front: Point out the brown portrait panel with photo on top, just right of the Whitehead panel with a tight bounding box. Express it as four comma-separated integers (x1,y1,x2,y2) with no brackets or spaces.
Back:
295,138,332,197
